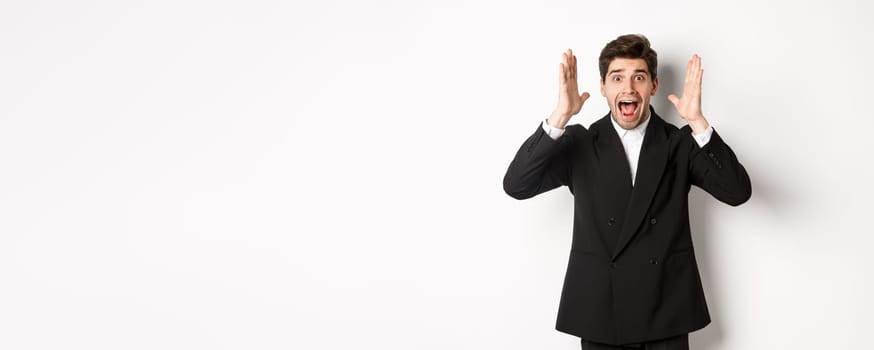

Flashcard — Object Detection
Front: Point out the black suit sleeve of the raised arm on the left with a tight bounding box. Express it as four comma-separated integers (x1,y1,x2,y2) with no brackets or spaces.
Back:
504,123,573,199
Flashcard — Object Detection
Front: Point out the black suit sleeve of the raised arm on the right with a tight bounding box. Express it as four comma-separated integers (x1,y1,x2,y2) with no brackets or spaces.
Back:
684,126,752,206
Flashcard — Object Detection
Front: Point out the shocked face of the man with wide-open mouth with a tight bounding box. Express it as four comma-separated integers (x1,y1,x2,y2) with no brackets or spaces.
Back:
601,58,659,129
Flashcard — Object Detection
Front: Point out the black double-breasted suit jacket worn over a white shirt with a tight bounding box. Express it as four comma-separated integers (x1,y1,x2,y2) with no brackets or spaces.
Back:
504,108,751,345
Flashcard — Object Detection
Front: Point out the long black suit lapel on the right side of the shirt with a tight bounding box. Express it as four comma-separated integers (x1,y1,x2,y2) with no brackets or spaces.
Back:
613,107,669,260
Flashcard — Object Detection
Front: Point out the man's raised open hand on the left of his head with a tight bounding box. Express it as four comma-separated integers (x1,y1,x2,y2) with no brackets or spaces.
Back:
547,49,589,129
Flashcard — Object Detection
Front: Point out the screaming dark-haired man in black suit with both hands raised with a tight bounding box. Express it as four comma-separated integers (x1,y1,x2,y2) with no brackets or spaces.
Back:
504,35,751,350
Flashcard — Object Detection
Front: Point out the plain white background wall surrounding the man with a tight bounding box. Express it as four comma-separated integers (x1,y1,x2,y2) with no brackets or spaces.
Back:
0,0,874,350
